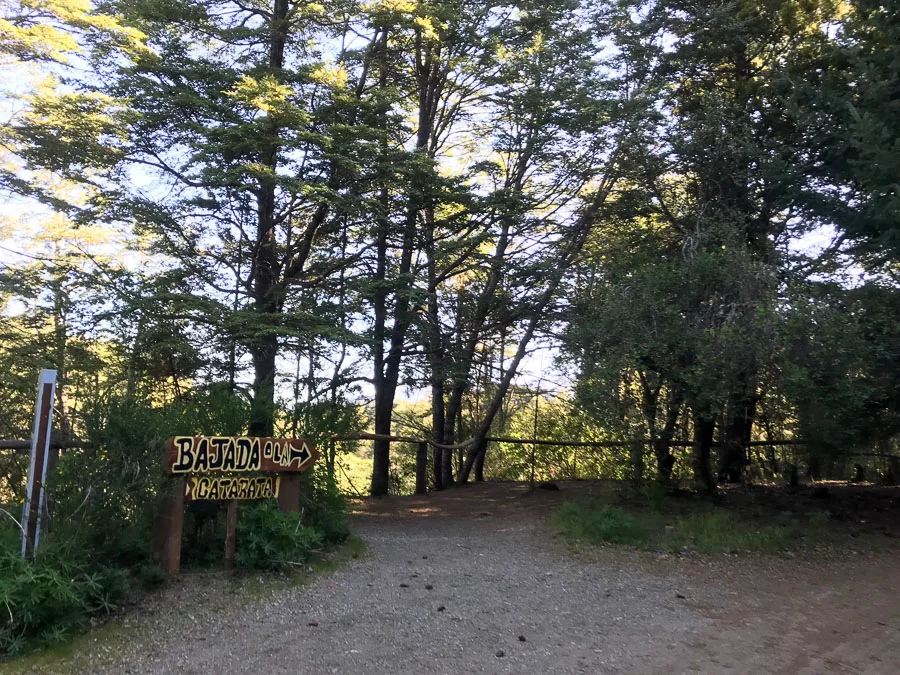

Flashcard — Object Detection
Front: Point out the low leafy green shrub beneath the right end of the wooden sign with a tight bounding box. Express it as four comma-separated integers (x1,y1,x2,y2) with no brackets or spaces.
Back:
235,502,324,569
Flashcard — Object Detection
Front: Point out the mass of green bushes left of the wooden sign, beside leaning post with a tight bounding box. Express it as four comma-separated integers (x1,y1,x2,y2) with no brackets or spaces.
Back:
0,389,258,652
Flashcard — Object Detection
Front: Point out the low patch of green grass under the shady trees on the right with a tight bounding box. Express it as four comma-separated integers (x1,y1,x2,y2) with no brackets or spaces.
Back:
552,502,827,555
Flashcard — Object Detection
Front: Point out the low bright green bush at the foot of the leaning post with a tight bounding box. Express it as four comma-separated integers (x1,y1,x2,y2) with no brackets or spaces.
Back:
0,536,130,654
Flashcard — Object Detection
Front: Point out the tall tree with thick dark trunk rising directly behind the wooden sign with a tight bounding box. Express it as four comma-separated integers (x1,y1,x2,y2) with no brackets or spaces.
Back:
70,0,378,436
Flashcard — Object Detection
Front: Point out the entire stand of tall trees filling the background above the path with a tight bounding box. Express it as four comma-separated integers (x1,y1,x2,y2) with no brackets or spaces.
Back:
0,0,900,494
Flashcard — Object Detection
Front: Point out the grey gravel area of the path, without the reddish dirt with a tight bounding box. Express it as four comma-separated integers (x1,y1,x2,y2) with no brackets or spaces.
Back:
102,518,709,673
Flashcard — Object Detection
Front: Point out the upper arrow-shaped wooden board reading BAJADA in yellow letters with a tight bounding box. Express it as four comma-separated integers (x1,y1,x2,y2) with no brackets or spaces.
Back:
166,436,318,474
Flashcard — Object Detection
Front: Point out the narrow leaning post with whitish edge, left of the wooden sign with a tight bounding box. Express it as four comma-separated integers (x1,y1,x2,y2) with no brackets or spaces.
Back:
22,370,56,556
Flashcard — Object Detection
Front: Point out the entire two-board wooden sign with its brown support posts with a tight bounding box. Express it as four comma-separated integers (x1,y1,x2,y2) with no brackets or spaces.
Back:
156,436,319,576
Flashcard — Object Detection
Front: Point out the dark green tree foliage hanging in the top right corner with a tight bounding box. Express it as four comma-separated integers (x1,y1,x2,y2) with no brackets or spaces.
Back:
780,0,900,270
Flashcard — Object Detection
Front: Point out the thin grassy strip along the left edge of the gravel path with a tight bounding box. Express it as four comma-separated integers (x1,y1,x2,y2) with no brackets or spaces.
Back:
0,536,366,675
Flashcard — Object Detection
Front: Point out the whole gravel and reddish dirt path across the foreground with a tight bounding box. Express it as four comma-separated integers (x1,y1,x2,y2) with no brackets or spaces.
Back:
8,486,900,674
